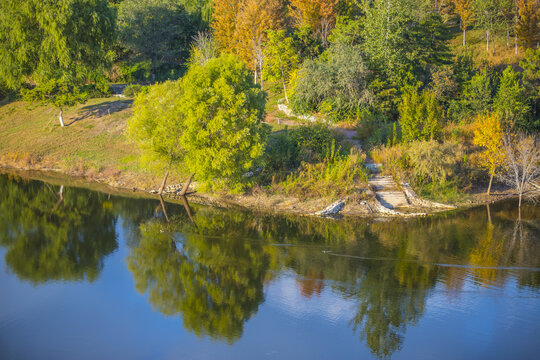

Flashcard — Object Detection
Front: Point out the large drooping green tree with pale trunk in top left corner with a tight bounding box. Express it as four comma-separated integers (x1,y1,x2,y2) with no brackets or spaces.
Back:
0,0,114,126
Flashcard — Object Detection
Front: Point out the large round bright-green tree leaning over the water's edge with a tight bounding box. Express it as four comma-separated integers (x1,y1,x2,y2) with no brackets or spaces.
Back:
128,55,268,189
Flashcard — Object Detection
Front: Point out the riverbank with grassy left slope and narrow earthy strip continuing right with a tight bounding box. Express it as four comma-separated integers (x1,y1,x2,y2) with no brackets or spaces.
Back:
0,97,513,216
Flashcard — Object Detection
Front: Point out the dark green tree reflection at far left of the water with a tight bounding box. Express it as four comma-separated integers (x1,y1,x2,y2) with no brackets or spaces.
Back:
0,176,117,284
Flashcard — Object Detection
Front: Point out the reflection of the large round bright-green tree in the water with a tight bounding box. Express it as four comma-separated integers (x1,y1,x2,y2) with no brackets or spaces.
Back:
128,209,269,342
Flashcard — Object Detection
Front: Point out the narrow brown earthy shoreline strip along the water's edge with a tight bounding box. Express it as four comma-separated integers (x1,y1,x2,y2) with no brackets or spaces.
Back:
0,162,517,219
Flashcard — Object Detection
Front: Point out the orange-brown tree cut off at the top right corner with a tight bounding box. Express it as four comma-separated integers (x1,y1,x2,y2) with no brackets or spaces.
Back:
516,0,540,48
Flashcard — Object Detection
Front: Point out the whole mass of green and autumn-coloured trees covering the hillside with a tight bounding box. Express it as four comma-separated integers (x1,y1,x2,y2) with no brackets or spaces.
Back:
0,0,540,205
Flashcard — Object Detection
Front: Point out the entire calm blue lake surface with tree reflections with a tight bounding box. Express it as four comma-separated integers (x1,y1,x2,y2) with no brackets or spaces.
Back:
0,175,540,360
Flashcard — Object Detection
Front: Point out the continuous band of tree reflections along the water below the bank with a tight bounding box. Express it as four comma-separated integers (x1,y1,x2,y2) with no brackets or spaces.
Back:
0,176,540,358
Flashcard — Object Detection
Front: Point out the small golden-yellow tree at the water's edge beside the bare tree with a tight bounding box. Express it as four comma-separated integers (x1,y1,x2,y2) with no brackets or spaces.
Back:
473,113,505,196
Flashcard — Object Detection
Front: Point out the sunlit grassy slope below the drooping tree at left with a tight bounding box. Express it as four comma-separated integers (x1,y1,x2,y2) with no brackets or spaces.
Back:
0,97,137,174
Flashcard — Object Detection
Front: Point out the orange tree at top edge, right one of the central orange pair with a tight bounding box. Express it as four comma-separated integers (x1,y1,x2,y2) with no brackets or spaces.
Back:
290,0,339,46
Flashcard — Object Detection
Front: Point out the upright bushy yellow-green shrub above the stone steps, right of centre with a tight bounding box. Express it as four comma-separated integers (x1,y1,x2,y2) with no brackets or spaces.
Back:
399,88,443,142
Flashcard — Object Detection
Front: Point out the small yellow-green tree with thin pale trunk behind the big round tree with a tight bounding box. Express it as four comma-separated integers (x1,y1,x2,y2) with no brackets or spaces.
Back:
263,30,300,103
